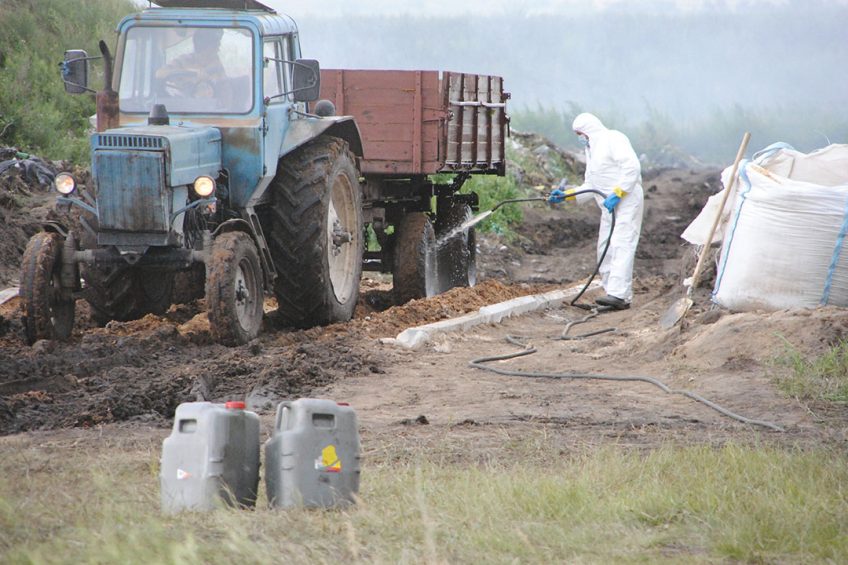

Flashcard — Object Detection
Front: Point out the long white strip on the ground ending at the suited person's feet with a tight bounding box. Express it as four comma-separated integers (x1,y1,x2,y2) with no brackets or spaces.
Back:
382,281,600,349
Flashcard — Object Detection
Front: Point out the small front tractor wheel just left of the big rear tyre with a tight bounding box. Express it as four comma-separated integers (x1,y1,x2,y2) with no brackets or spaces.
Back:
206,232,265,345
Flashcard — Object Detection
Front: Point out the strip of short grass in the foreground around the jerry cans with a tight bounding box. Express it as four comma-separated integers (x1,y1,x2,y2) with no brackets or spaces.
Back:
0,430,848,563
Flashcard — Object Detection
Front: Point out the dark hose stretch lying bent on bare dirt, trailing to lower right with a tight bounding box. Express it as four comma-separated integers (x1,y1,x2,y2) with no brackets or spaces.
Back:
468,336,784,432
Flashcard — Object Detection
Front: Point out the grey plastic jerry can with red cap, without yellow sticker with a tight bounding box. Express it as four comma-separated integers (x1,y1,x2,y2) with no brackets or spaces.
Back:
159,402,259,512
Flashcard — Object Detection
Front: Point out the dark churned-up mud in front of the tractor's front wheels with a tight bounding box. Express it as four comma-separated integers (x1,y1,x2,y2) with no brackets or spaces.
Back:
0,299,381,434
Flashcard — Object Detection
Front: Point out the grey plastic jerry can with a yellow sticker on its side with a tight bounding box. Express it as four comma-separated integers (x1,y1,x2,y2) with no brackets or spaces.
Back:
265,398,361,508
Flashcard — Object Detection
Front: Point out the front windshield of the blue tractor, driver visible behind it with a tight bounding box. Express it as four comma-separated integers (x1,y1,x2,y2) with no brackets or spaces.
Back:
119,26,253,114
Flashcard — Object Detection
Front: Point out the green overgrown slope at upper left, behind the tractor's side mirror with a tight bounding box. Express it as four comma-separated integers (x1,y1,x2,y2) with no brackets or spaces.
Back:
0,0,137,164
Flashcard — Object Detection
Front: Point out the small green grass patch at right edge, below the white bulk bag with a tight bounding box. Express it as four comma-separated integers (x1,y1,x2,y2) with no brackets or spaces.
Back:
776,340,848,402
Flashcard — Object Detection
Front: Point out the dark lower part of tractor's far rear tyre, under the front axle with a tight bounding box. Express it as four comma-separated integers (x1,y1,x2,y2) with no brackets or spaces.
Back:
82,265,174,326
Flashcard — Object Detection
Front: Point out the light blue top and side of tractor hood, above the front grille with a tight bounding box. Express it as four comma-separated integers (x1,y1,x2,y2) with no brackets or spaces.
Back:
91,126,221,186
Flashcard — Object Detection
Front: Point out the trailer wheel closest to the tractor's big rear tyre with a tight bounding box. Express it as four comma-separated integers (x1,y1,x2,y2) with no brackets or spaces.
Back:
392,212,439,304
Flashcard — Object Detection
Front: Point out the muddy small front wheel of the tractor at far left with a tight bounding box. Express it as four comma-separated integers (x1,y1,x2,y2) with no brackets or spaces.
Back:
21,232,74,344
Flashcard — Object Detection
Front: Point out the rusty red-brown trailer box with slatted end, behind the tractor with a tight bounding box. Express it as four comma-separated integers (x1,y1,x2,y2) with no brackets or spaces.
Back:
321,69,508,175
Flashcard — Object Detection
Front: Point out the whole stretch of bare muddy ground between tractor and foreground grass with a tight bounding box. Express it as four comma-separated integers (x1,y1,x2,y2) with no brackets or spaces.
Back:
0,137,848,451
